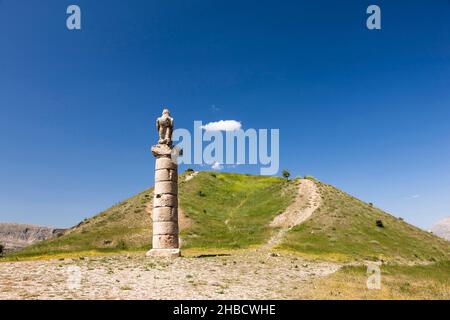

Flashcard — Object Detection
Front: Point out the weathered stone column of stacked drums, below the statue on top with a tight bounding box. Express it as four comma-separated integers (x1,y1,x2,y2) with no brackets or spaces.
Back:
147,144,180,257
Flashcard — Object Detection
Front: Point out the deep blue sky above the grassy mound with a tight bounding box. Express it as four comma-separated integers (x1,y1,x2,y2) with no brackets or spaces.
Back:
0,0,450,228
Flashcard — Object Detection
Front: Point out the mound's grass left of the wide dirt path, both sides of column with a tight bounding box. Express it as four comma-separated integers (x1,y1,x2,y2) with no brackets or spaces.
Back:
14,172,295,257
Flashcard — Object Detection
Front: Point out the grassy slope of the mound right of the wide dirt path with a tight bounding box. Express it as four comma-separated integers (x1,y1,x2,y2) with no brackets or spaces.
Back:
281,180,450,261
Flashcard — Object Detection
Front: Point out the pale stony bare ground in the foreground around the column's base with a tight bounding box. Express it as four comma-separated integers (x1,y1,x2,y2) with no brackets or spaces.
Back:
0,250,339,299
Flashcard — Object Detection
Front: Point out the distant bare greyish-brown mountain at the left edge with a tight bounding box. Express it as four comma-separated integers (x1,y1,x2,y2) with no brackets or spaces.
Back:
0,223,64,251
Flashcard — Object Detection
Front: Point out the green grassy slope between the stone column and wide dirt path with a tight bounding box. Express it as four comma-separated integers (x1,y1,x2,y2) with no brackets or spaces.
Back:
180,172,295,248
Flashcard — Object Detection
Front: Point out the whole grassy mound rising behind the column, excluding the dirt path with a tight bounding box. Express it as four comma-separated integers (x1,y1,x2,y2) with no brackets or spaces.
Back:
5,172,450,261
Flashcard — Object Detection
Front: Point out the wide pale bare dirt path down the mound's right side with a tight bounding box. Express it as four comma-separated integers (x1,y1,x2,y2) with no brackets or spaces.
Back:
265,179,322,248
